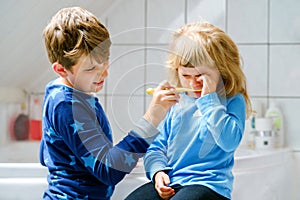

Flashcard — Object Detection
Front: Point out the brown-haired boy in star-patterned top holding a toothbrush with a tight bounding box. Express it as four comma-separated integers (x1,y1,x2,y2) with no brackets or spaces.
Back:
40,7,178,199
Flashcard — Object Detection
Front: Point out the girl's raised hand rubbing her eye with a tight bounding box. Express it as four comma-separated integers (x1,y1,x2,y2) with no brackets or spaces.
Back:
197,66,220,97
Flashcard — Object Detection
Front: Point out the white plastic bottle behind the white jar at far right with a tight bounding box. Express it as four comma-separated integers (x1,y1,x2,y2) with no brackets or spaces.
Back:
265,102,285,148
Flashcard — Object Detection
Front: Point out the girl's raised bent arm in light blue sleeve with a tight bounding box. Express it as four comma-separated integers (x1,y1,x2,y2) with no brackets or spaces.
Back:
197,93,246,151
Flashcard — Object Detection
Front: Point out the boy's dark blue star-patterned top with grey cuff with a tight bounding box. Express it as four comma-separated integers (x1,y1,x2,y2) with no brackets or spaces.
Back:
40,82,158,199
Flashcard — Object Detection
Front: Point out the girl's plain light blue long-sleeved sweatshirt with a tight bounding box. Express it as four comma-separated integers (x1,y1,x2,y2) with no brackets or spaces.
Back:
144,93,246,199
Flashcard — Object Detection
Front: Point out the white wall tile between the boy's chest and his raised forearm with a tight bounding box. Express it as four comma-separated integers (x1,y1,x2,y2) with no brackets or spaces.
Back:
107,95,144,142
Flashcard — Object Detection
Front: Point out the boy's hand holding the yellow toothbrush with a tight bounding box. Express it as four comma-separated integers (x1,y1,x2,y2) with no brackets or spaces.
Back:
144,81,179,126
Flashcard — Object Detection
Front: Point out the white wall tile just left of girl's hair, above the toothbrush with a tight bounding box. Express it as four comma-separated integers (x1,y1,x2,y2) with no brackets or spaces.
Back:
146,45,169,87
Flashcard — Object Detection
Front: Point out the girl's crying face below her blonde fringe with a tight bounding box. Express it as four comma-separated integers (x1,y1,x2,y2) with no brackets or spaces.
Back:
178,66,203,98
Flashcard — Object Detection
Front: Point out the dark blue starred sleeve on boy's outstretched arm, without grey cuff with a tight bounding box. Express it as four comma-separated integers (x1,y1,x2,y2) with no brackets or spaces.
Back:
51,102,149,186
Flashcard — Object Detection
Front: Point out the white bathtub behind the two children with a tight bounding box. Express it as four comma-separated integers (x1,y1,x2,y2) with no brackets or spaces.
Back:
0,142,297,200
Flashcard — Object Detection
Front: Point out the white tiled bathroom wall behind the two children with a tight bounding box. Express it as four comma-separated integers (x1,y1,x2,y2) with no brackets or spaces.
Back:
100,0,300,198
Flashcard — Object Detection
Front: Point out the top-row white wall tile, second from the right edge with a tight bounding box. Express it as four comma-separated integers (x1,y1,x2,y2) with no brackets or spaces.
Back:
228,0,268,43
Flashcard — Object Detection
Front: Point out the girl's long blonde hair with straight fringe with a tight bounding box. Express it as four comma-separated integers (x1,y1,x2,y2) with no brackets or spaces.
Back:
167,22,251,114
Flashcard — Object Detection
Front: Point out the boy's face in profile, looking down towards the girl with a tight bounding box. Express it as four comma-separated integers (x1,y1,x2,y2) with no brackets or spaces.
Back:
66,55,109,93
